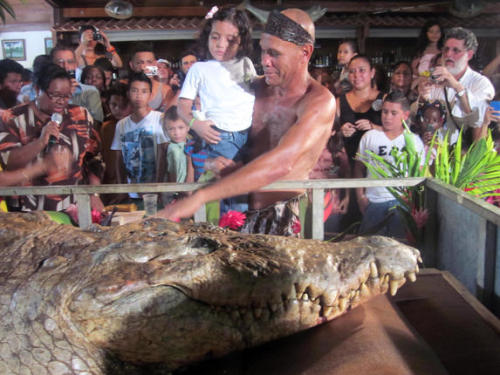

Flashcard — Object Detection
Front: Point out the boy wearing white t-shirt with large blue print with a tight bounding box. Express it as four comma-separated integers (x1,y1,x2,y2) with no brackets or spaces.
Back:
111,72,168,198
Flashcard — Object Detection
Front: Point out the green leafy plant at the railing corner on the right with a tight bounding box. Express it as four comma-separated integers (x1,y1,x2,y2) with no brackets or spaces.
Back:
360,123,500,243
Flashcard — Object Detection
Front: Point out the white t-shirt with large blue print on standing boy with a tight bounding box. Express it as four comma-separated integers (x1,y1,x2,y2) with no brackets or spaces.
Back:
111,111,169,183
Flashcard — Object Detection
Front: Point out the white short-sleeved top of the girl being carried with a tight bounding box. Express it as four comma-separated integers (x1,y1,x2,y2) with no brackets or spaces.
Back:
180,57,255,132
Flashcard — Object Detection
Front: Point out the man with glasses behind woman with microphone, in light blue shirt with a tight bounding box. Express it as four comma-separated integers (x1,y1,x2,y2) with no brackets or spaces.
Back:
50,45,104,122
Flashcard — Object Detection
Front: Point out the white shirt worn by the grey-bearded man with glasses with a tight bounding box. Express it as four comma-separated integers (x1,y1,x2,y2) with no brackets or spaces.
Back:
430,67,495,129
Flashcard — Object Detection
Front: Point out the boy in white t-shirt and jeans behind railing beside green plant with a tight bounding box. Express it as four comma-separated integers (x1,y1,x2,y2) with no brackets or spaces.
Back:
354,91,424,238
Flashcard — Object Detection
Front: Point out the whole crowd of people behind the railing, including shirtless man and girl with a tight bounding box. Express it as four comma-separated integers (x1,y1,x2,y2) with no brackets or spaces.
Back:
0,8,500,241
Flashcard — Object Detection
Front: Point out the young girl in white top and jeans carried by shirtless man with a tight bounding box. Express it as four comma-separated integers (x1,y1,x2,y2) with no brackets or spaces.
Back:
178,7,256,164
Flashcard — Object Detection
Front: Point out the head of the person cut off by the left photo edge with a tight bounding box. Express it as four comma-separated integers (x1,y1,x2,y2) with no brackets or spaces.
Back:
0,59,24,109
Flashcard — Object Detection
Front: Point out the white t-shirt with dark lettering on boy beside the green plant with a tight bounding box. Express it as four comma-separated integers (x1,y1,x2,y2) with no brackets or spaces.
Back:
358,129,424,203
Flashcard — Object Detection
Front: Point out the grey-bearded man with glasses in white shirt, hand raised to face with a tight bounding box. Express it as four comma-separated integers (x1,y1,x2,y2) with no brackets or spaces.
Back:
419,27,495,140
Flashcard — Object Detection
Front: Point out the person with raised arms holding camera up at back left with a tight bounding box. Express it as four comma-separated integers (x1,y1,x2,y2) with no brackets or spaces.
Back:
75,25,123,68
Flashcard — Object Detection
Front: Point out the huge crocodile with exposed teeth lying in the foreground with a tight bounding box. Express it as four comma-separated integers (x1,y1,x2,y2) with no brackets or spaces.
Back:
0,212,420,375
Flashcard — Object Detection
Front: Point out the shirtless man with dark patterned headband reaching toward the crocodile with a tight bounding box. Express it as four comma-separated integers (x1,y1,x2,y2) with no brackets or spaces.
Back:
158,9,335,234
